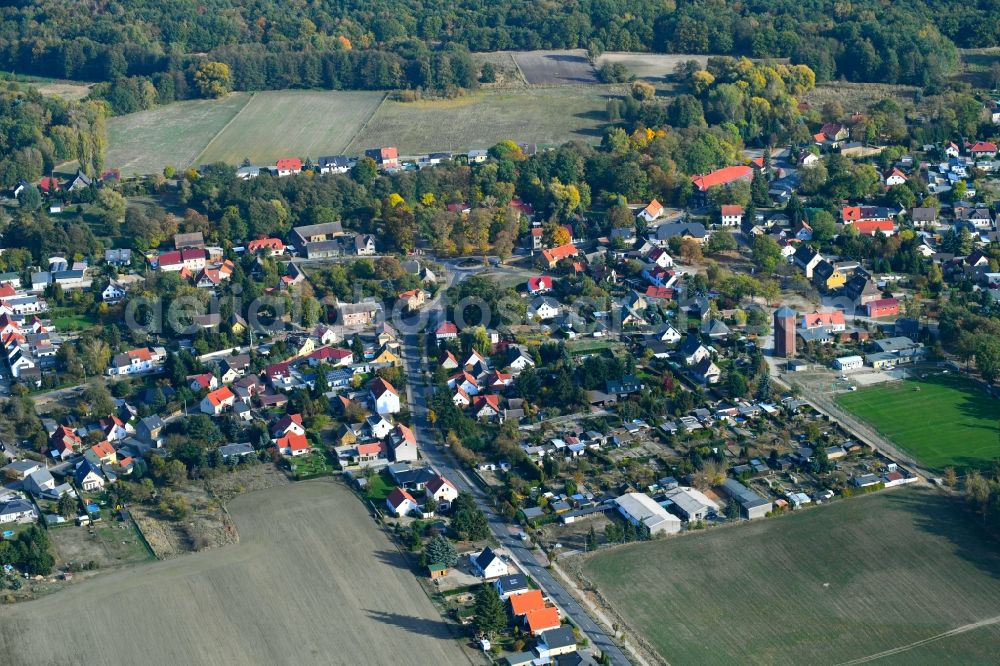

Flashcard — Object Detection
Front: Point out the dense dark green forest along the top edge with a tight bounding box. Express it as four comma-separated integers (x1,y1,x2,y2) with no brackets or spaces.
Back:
0,0,984,110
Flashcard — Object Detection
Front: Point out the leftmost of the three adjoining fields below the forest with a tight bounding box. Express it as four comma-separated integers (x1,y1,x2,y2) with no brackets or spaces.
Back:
105,93,250,175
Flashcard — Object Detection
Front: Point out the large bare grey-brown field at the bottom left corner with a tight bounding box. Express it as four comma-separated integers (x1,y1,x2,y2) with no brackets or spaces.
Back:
0,481,469,666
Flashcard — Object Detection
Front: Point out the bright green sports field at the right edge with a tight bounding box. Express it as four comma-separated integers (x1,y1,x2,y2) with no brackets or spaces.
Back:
837,374,1000,470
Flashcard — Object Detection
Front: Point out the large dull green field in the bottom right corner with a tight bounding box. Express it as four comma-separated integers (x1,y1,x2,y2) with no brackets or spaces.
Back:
583,488,1000,666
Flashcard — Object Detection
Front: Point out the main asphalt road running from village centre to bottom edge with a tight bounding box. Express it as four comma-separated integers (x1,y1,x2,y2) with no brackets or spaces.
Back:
402,267,630,666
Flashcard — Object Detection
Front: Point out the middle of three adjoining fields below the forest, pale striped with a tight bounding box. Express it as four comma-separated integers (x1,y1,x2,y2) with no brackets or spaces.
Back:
194,90,385,164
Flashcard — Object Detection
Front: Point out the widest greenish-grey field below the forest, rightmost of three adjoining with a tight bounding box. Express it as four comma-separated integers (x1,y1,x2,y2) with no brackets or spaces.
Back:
347,86,614,155
